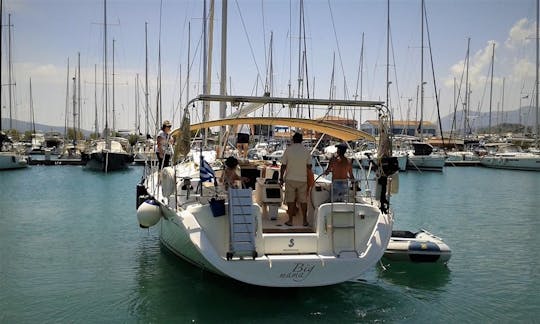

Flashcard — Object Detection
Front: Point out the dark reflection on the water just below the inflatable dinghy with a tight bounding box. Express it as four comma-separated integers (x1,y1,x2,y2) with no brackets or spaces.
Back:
377,259,450,291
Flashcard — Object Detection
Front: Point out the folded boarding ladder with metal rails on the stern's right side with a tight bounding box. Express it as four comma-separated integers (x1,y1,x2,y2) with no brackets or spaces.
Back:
330,179,359,257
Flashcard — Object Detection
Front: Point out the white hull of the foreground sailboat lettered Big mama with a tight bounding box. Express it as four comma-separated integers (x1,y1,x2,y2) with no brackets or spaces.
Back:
160,201,393,287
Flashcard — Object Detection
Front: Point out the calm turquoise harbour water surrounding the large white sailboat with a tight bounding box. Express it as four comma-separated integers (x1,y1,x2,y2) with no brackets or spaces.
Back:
0,166,540,323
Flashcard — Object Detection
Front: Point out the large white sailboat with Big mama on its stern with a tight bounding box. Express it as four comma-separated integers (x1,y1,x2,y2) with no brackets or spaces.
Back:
137,95,397,287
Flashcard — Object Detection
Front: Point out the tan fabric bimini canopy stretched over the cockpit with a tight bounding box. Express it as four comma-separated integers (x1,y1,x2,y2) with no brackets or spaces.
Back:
186,117,375,141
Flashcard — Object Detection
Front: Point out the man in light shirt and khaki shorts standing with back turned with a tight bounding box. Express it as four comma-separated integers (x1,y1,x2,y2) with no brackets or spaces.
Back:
279,133,311,226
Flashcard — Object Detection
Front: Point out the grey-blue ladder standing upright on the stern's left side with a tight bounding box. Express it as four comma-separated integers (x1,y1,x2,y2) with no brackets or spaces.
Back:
227,188,257,260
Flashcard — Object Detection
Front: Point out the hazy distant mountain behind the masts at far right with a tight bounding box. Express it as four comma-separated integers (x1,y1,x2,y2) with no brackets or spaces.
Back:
441,106,536,132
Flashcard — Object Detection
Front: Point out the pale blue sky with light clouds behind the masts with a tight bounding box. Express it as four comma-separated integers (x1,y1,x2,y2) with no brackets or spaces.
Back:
1,0,536,132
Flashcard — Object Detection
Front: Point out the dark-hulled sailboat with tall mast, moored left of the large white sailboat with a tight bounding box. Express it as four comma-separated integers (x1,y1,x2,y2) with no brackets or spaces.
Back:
82,0,133,172
